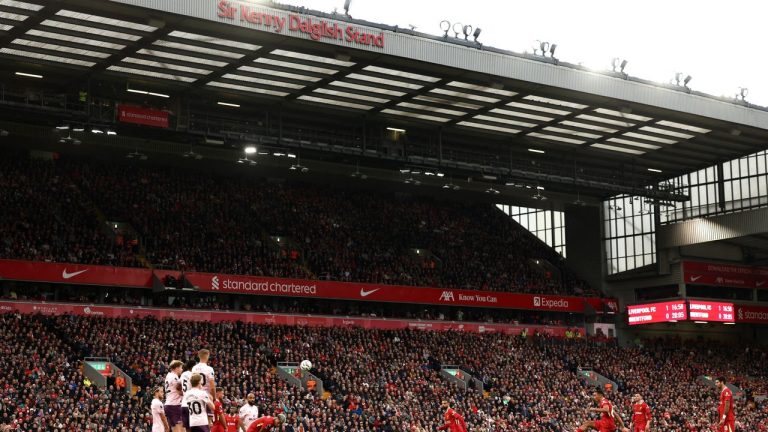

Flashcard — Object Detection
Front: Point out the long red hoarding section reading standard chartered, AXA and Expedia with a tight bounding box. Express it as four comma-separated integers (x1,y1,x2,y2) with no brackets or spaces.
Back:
184,273,611,312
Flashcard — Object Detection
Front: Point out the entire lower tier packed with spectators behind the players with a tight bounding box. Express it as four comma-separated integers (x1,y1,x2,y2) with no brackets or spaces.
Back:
0,314,768,432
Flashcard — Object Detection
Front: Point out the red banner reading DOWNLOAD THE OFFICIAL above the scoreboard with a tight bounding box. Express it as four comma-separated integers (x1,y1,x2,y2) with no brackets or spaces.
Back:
683,261,768,288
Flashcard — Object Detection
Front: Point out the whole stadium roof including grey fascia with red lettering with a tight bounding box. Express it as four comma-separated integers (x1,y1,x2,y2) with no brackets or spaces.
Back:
0,0,768,199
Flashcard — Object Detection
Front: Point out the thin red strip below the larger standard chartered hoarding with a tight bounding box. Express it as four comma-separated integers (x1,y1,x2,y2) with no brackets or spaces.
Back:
0,301,584,337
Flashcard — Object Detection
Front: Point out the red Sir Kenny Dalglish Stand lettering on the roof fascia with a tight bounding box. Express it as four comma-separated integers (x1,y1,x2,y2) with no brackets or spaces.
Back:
216,0,384,48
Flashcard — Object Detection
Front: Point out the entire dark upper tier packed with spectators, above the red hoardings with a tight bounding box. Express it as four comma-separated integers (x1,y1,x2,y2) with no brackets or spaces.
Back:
0,149,596,295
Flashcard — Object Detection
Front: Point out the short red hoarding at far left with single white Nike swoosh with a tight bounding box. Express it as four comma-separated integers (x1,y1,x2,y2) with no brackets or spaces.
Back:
0,260,153,288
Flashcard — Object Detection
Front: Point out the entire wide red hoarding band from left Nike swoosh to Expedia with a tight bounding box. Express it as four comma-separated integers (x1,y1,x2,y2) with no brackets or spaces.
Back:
0,260,618,313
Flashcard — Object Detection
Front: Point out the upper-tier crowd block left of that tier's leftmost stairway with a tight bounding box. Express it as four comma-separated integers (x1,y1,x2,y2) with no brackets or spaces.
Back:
0,152,137,266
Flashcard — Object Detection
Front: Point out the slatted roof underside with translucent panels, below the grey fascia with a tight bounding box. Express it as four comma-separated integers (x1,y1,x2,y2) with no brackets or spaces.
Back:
0,0,768,184
